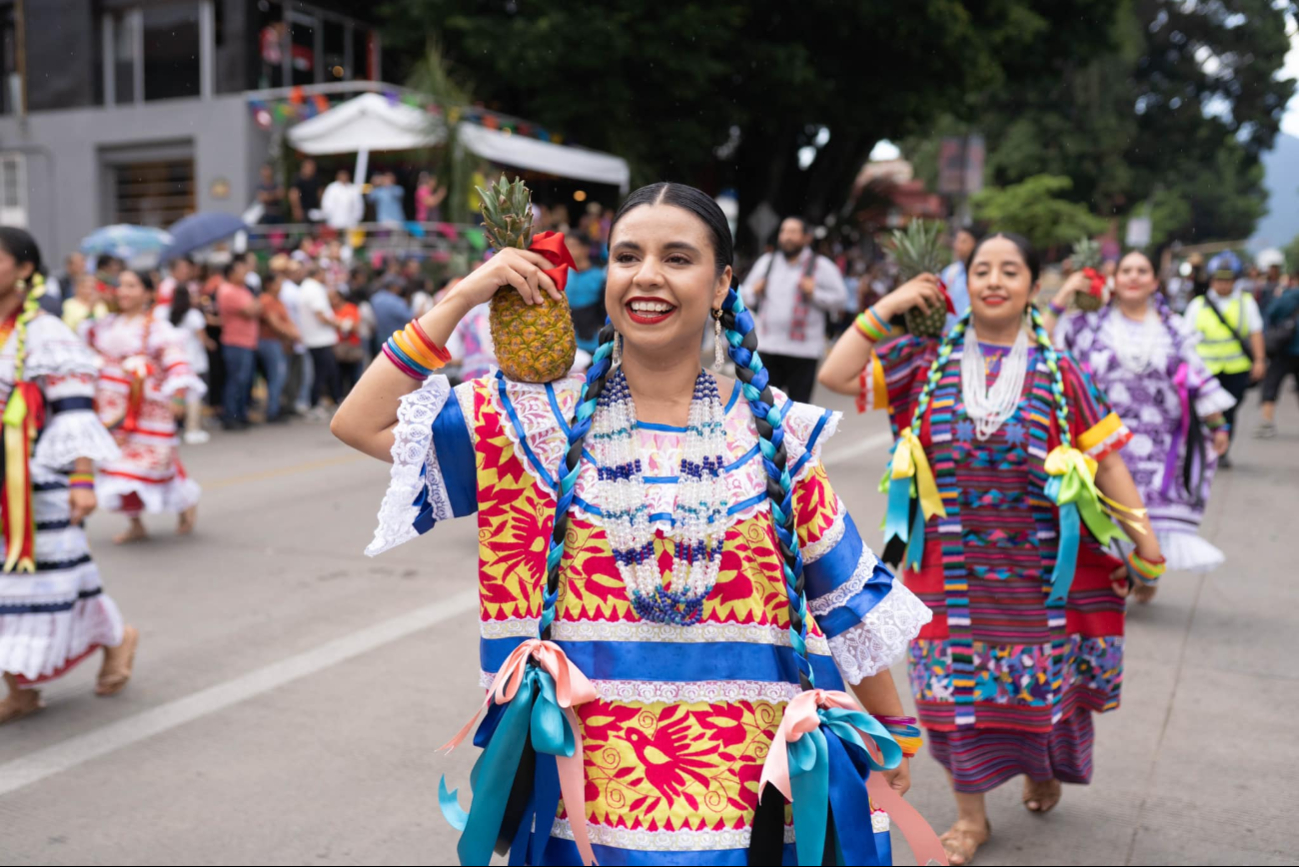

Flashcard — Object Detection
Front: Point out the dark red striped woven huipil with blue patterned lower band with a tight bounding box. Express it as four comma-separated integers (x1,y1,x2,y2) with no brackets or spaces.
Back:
860,337,1131,738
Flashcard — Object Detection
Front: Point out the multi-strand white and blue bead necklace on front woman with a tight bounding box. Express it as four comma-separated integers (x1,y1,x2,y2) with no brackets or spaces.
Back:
591,367,727,625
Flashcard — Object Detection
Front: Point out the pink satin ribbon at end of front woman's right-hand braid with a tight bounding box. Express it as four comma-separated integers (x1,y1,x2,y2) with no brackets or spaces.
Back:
757,689,948,867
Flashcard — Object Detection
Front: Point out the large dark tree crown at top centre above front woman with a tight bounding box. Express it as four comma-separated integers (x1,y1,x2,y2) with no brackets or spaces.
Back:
381,0,1120,244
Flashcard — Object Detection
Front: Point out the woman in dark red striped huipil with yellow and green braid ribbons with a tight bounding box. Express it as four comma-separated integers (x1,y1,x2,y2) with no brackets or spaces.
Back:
821,234,1164,864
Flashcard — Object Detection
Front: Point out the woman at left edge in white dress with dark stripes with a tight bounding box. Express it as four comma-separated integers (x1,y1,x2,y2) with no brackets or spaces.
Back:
0,226,138,723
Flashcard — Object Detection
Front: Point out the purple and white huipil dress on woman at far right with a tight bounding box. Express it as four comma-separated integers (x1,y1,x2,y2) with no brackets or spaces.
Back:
1056,307,1235,571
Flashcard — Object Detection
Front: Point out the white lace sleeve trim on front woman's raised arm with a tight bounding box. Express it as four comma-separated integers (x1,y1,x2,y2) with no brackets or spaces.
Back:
365,376,452,556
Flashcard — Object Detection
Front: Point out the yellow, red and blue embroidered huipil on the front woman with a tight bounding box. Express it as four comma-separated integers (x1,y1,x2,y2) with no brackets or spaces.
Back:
368,376,930,864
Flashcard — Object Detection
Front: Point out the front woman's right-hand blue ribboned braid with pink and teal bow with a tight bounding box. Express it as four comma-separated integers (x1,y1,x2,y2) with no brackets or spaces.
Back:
721,287,947,864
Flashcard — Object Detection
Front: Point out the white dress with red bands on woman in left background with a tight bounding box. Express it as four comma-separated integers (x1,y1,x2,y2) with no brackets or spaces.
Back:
83,315,207,512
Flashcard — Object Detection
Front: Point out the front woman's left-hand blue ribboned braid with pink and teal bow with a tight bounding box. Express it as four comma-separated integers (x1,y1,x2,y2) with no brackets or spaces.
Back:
428,325,613,864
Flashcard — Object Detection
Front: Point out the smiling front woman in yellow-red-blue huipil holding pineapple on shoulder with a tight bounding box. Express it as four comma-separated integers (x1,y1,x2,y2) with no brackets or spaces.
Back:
334,181,942,864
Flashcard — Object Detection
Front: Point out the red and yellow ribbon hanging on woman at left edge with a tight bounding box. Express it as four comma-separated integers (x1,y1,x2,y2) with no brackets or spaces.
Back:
0,382,45,572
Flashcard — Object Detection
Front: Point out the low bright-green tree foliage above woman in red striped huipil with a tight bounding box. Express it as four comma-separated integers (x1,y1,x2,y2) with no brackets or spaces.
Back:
970,174,1105,251
